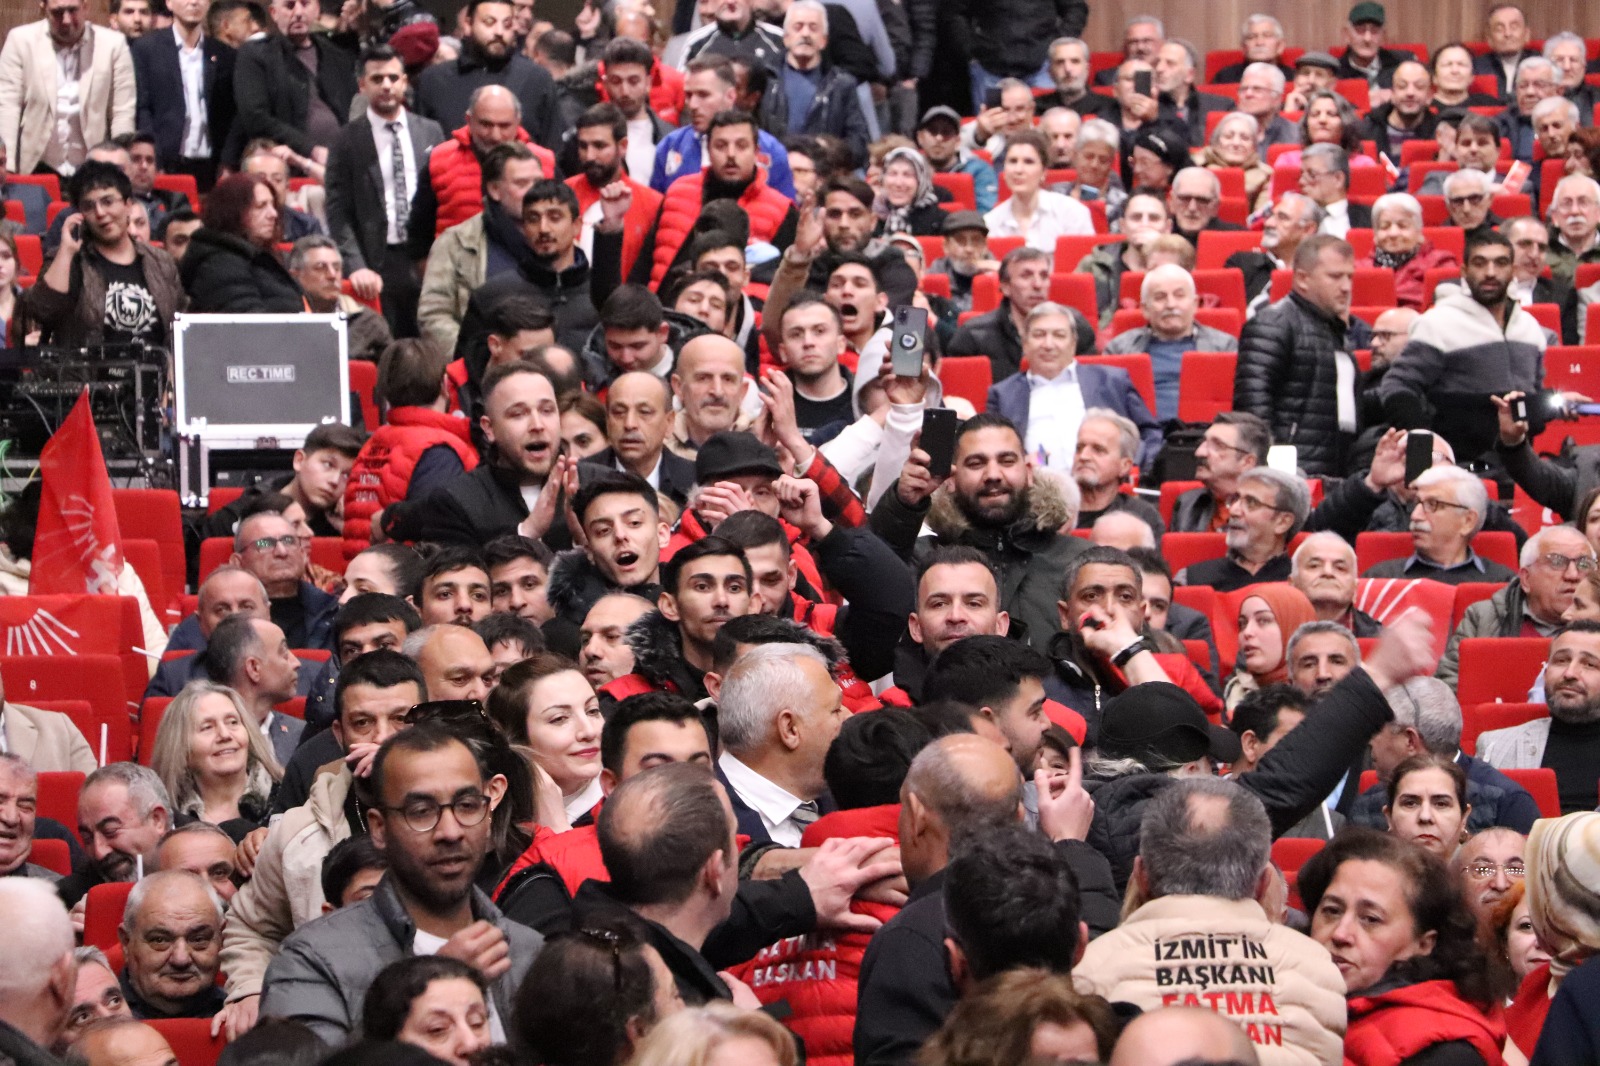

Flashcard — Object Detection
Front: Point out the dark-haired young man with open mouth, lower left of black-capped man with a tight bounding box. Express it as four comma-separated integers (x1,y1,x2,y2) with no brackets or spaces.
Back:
549,471,672,634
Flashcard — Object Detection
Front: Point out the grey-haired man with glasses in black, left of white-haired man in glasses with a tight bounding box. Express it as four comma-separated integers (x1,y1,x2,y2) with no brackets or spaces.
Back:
1176,466,1310,592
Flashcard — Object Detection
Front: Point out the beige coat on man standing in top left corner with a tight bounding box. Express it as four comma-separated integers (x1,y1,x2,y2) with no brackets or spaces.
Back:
0,19,138,174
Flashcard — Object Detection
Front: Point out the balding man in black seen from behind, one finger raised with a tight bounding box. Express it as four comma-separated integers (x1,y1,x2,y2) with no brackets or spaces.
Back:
854,733,1120,1063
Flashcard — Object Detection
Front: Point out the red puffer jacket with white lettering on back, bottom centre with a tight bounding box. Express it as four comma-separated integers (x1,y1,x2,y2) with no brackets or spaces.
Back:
733,804,899,1066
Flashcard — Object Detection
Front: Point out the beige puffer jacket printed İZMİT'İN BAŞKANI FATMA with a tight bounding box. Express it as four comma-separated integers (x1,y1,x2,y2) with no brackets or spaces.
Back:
1072,896,1344,1066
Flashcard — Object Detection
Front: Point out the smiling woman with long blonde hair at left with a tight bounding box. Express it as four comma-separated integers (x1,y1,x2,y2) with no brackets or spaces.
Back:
150,680,283,837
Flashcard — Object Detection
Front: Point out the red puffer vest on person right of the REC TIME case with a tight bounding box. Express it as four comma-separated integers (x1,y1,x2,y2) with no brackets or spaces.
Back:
344,407,478,559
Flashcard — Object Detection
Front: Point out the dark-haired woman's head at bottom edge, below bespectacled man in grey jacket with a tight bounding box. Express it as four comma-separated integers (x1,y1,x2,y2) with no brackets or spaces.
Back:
362,956,493,1066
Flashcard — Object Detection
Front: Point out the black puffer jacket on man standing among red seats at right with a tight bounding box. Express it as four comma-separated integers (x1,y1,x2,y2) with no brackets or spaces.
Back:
1234,293,1371,477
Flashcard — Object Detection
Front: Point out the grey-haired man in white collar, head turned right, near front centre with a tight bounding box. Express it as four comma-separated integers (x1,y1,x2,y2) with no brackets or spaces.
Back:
717,643,848,847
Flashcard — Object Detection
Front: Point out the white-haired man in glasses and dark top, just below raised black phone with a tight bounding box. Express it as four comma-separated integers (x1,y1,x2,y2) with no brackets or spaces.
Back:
1365,466,1517,584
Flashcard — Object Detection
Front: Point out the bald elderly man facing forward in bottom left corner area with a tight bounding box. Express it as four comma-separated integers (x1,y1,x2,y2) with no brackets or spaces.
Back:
117,869,222,1020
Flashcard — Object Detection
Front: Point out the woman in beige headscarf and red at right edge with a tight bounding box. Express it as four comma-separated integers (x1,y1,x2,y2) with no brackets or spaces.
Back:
1506,812,1600,1061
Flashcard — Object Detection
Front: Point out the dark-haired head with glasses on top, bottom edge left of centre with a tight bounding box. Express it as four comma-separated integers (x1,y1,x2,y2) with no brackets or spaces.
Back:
510,919,683,1066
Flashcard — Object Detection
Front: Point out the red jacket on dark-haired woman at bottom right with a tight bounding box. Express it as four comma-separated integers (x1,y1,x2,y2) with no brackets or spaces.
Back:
1344,981,1506,1066
